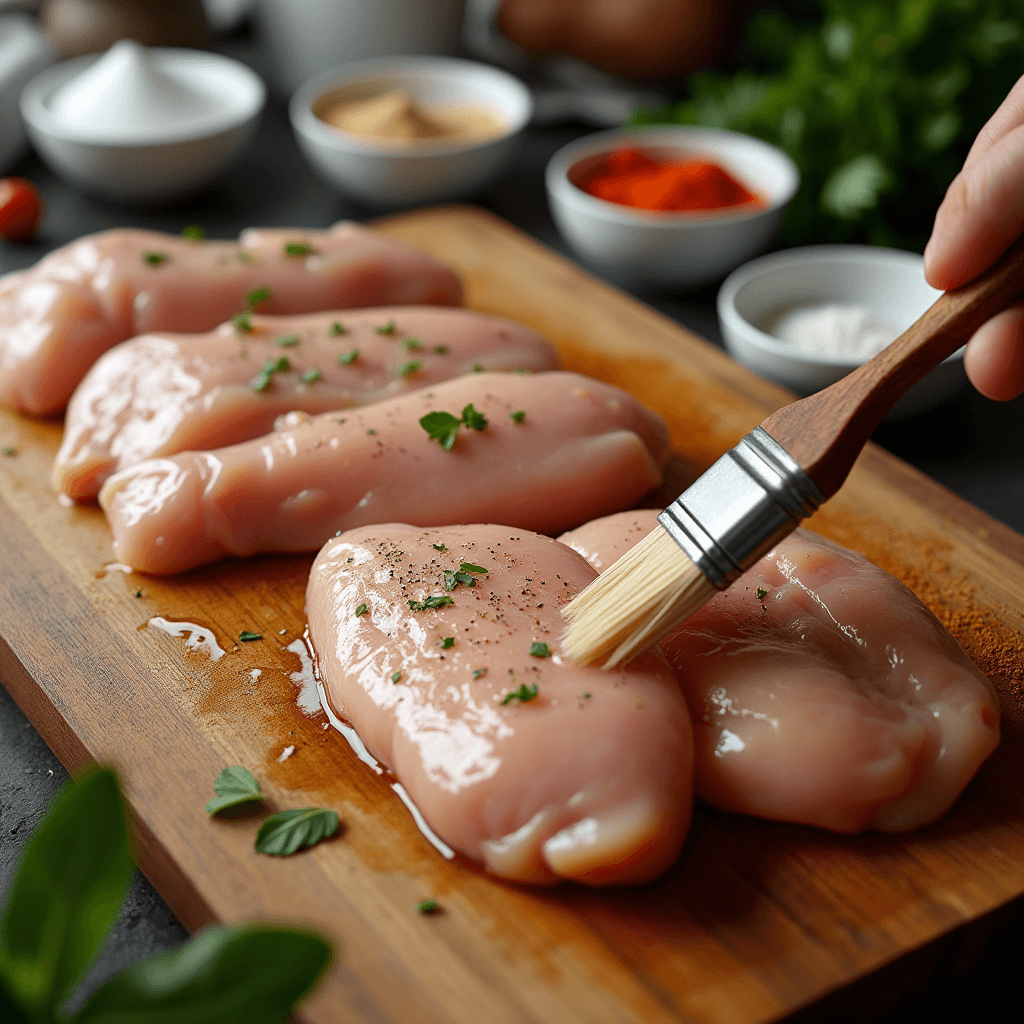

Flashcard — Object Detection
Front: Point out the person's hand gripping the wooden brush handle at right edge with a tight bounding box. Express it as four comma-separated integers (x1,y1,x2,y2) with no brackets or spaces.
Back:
925,72,1024,401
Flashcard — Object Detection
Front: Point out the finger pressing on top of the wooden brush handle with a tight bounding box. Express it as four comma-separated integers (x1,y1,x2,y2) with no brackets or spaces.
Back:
925,126,1024,290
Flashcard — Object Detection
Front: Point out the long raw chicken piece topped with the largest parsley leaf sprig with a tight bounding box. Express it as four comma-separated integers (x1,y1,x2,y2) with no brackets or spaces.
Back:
99,373,669,572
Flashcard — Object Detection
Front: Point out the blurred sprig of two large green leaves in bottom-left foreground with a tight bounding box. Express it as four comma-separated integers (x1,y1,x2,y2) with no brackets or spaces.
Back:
0,769,331,1024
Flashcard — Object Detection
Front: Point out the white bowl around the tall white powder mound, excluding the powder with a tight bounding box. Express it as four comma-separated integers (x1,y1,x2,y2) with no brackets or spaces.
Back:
20,48,266,204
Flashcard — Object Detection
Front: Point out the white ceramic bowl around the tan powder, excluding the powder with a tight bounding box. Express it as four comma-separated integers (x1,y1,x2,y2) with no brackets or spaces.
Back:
290,56,534,208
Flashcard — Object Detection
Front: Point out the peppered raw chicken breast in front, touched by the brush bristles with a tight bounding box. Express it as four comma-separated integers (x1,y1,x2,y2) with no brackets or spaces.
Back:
306,524,692,885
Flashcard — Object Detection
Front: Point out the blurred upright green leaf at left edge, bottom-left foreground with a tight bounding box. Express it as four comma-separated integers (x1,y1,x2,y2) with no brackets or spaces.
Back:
0,769,135,1020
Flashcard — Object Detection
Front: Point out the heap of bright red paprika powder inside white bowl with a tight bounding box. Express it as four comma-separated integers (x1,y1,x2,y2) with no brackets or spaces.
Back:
580,150,764,211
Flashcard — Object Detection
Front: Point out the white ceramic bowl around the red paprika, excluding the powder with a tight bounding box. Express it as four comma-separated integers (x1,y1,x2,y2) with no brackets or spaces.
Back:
546,126,800,288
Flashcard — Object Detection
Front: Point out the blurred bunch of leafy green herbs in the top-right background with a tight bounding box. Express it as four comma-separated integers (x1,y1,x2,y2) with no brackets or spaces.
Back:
635,0,1024,251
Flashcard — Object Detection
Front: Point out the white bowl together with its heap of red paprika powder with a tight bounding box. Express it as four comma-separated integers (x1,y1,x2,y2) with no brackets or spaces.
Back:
546,126,800,289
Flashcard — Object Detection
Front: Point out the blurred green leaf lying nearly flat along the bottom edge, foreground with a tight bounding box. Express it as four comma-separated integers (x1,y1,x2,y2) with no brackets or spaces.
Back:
72,926,331,1024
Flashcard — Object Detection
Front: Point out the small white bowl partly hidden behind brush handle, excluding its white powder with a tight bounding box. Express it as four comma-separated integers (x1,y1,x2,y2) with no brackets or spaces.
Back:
718,246,967,418
